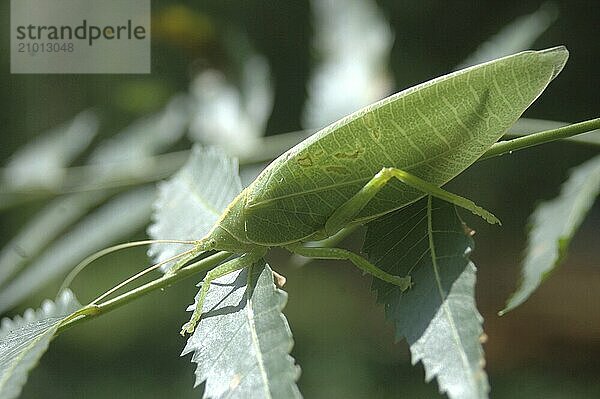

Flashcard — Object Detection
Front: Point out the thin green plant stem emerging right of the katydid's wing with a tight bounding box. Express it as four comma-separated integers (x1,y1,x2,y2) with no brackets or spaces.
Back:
479,118,600,161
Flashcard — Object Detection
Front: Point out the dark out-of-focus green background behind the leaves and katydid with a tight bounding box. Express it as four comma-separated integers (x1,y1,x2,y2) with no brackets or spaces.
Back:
0,0,600,398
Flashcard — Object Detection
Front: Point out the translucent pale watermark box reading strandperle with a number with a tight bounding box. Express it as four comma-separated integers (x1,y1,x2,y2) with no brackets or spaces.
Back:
10,0,150,73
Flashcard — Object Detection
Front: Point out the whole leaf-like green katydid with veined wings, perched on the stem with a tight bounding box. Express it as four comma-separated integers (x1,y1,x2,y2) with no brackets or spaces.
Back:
63,46,568,334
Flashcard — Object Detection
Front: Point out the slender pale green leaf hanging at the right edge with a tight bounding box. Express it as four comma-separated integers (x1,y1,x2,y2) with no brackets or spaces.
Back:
500,156,600,314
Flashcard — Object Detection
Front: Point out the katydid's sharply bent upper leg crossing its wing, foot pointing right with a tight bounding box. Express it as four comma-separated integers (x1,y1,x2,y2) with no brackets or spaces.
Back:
325,168,500,236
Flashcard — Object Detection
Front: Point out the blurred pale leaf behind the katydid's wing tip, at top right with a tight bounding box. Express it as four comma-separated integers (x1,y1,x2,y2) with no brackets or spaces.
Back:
455,2,558,70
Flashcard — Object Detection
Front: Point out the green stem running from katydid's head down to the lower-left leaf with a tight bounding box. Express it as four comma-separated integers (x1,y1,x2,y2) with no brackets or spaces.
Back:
57,251,232,333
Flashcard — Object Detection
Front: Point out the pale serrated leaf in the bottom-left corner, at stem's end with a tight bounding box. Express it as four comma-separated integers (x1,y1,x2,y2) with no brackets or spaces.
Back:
0,290,81,399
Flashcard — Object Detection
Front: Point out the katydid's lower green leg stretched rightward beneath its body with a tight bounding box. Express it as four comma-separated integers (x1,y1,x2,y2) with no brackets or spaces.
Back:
287,245,412,291
